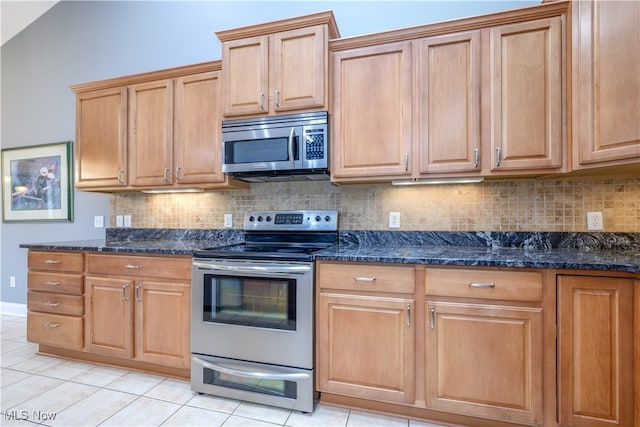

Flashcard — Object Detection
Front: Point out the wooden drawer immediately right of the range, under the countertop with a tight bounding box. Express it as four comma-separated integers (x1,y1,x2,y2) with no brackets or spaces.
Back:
318,263,415,293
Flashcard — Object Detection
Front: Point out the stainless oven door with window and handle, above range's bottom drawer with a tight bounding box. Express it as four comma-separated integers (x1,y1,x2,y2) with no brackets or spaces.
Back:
191,259,314,369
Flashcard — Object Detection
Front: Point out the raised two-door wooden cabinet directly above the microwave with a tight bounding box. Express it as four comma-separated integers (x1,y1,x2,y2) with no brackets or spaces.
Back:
216,12,339,117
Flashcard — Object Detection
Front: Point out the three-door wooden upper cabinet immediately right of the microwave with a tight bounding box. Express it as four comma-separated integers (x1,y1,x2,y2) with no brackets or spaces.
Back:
330,3,568,182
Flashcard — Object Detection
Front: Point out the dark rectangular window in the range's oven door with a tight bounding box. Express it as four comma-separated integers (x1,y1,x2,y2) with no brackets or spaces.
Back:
203,274,296,331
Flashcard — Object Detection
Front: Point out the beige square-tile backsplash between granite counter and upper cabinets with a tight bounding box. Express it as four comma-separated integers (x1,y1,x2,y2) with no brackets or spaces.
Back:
110,177,640,232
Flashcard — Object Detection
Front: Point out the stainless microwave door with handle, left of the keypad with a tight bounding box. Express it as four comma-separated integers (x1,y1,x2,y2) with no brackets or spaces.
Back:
222,126,302,174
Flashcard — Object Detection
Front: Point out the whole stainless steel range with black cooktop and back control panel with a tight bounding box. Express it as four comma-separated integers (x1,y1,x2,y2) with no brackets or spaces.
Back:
191,210,338,412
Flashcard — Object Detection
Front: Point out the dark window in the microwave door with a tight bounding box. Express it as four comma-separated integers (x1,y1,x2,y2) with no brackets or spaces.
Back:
225,136,298,164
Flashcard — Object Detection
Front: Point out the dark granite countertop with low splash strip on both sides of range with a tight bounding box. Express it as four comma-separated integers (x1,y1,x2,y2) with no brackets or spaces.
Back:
20,229,640,273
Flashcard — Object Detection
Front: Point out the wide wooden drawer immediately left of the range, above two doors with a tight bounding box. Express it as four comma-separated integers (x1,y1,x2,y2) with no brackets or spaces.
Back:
87,254,191,280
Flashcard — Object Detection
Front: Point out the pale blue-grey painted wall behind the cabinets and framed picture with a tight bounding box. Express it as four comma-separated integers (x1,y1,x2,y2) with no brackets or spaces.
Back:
0,1,539,304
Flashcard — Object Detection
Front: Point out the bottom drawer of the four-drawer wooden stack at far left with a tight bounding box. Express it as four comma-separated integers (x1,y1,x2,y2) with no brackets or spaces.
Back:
27,311,83,350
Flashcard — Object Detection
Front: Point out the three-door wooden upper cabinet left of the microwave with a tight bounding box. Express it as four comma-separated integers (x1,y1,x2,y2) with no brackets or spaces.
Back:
72,61,246,191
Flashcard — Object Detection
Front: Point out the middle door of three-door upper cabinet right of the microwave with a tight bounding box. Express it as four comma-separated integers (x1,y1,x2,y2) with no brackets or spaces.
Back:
418,31,481,174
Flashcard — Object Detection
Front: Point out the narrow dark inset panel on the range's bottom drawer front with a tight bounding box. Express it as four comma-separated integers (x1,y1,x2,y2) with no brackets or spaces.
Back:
202,368,298,399
